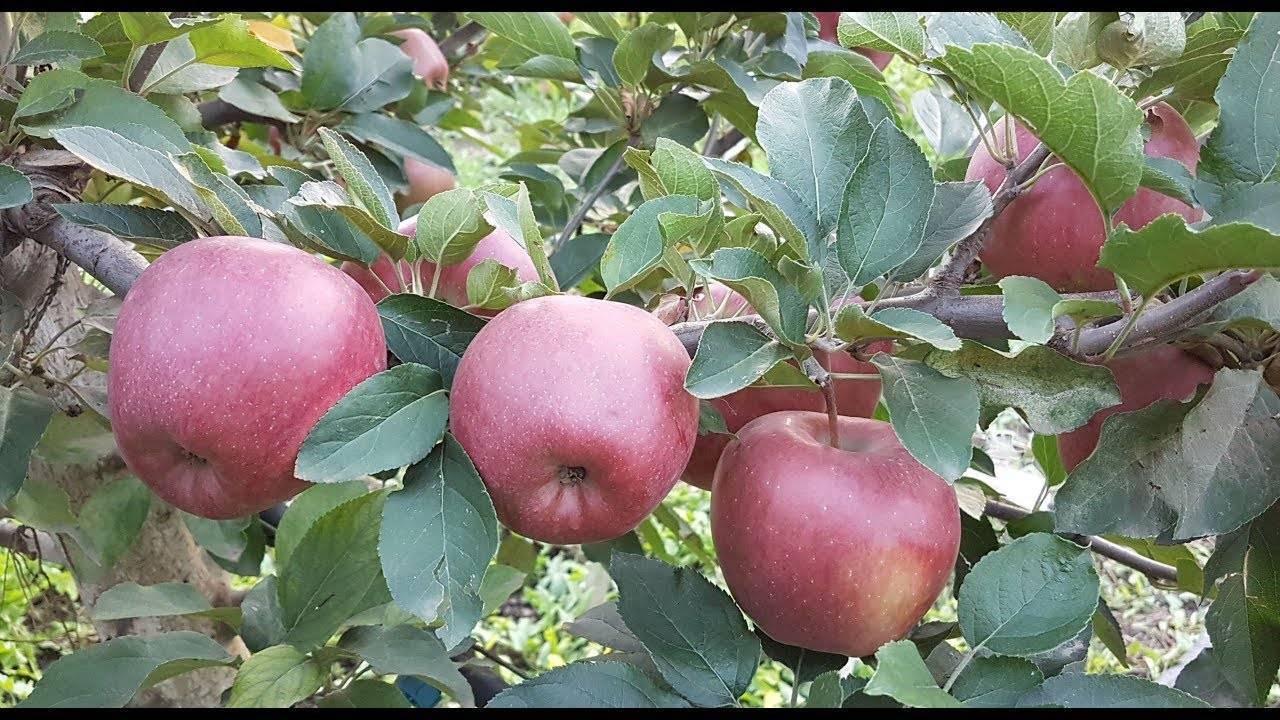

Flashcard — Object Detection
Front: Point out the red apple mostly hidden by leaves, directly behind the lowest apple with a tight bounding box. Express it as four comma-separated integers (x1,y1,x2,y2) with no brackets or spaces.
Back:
682,283,892,489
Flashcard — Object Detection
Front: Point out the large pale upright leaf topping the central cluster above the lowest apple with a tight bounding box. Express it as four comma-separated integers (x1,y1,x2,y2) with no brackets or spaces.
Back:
755,78,873,238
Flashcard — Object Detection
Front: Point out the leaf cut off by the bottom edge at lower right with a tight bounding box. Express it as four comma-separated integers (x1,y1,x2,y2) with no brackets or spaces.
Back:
1018,673,1208,710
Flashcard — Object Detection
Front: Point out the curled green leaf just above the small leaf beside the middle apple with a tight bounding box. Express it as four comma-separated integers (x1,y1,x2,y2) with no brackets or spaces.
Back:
690,247,809,350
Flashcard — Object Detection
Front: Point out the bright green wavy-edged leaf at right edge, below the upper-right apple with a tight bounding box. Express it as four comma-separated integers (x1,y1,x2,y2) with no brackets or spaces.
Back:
1098,213,1280,297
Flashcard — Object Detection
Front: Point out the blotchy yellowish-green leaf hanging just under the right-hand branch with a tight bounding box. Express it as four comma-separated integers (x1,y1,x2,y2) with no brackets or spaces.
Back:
924,341,1120,434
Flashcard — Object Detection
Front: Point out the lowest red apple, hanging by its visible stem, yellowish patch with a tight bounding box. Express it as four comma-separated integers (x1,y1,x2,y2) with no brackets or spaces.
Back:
712,411,960,657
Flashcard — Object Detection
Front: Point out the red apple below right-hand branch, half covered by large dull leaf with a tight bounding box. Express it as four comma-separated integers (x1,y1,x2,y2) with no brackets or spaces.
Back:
1057,345,1213,470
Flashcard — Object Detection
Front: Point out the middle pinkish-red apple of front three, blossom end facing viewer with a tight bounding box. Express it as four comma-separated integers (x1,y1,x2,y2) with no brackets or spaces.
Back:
449,295,698,544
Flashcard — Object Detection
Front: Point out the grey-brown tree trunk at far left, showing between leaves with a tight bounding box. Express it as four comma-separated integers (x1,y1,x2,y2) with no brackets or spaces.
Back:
0,236,247,707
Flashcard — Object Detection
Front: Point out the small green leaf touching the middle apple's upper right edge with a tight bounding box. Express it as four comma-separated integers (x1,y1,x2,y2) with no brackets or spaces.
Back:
685,320,794,400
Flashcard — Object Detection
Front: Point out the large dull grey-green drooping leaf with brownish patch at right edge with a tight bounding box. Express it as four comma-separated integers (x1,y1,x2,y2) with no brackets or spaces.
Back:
1053,368,1280,541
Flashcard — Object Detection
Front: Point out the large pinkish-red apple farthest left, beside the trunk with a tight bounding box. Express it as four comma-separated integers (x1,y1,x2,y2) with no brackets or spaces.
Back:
108,237,387,519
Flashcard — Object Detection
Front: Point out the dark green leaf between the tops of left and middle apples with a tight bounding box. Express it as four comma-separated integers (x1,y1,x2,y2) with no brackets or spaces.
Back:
378,293,485,386
